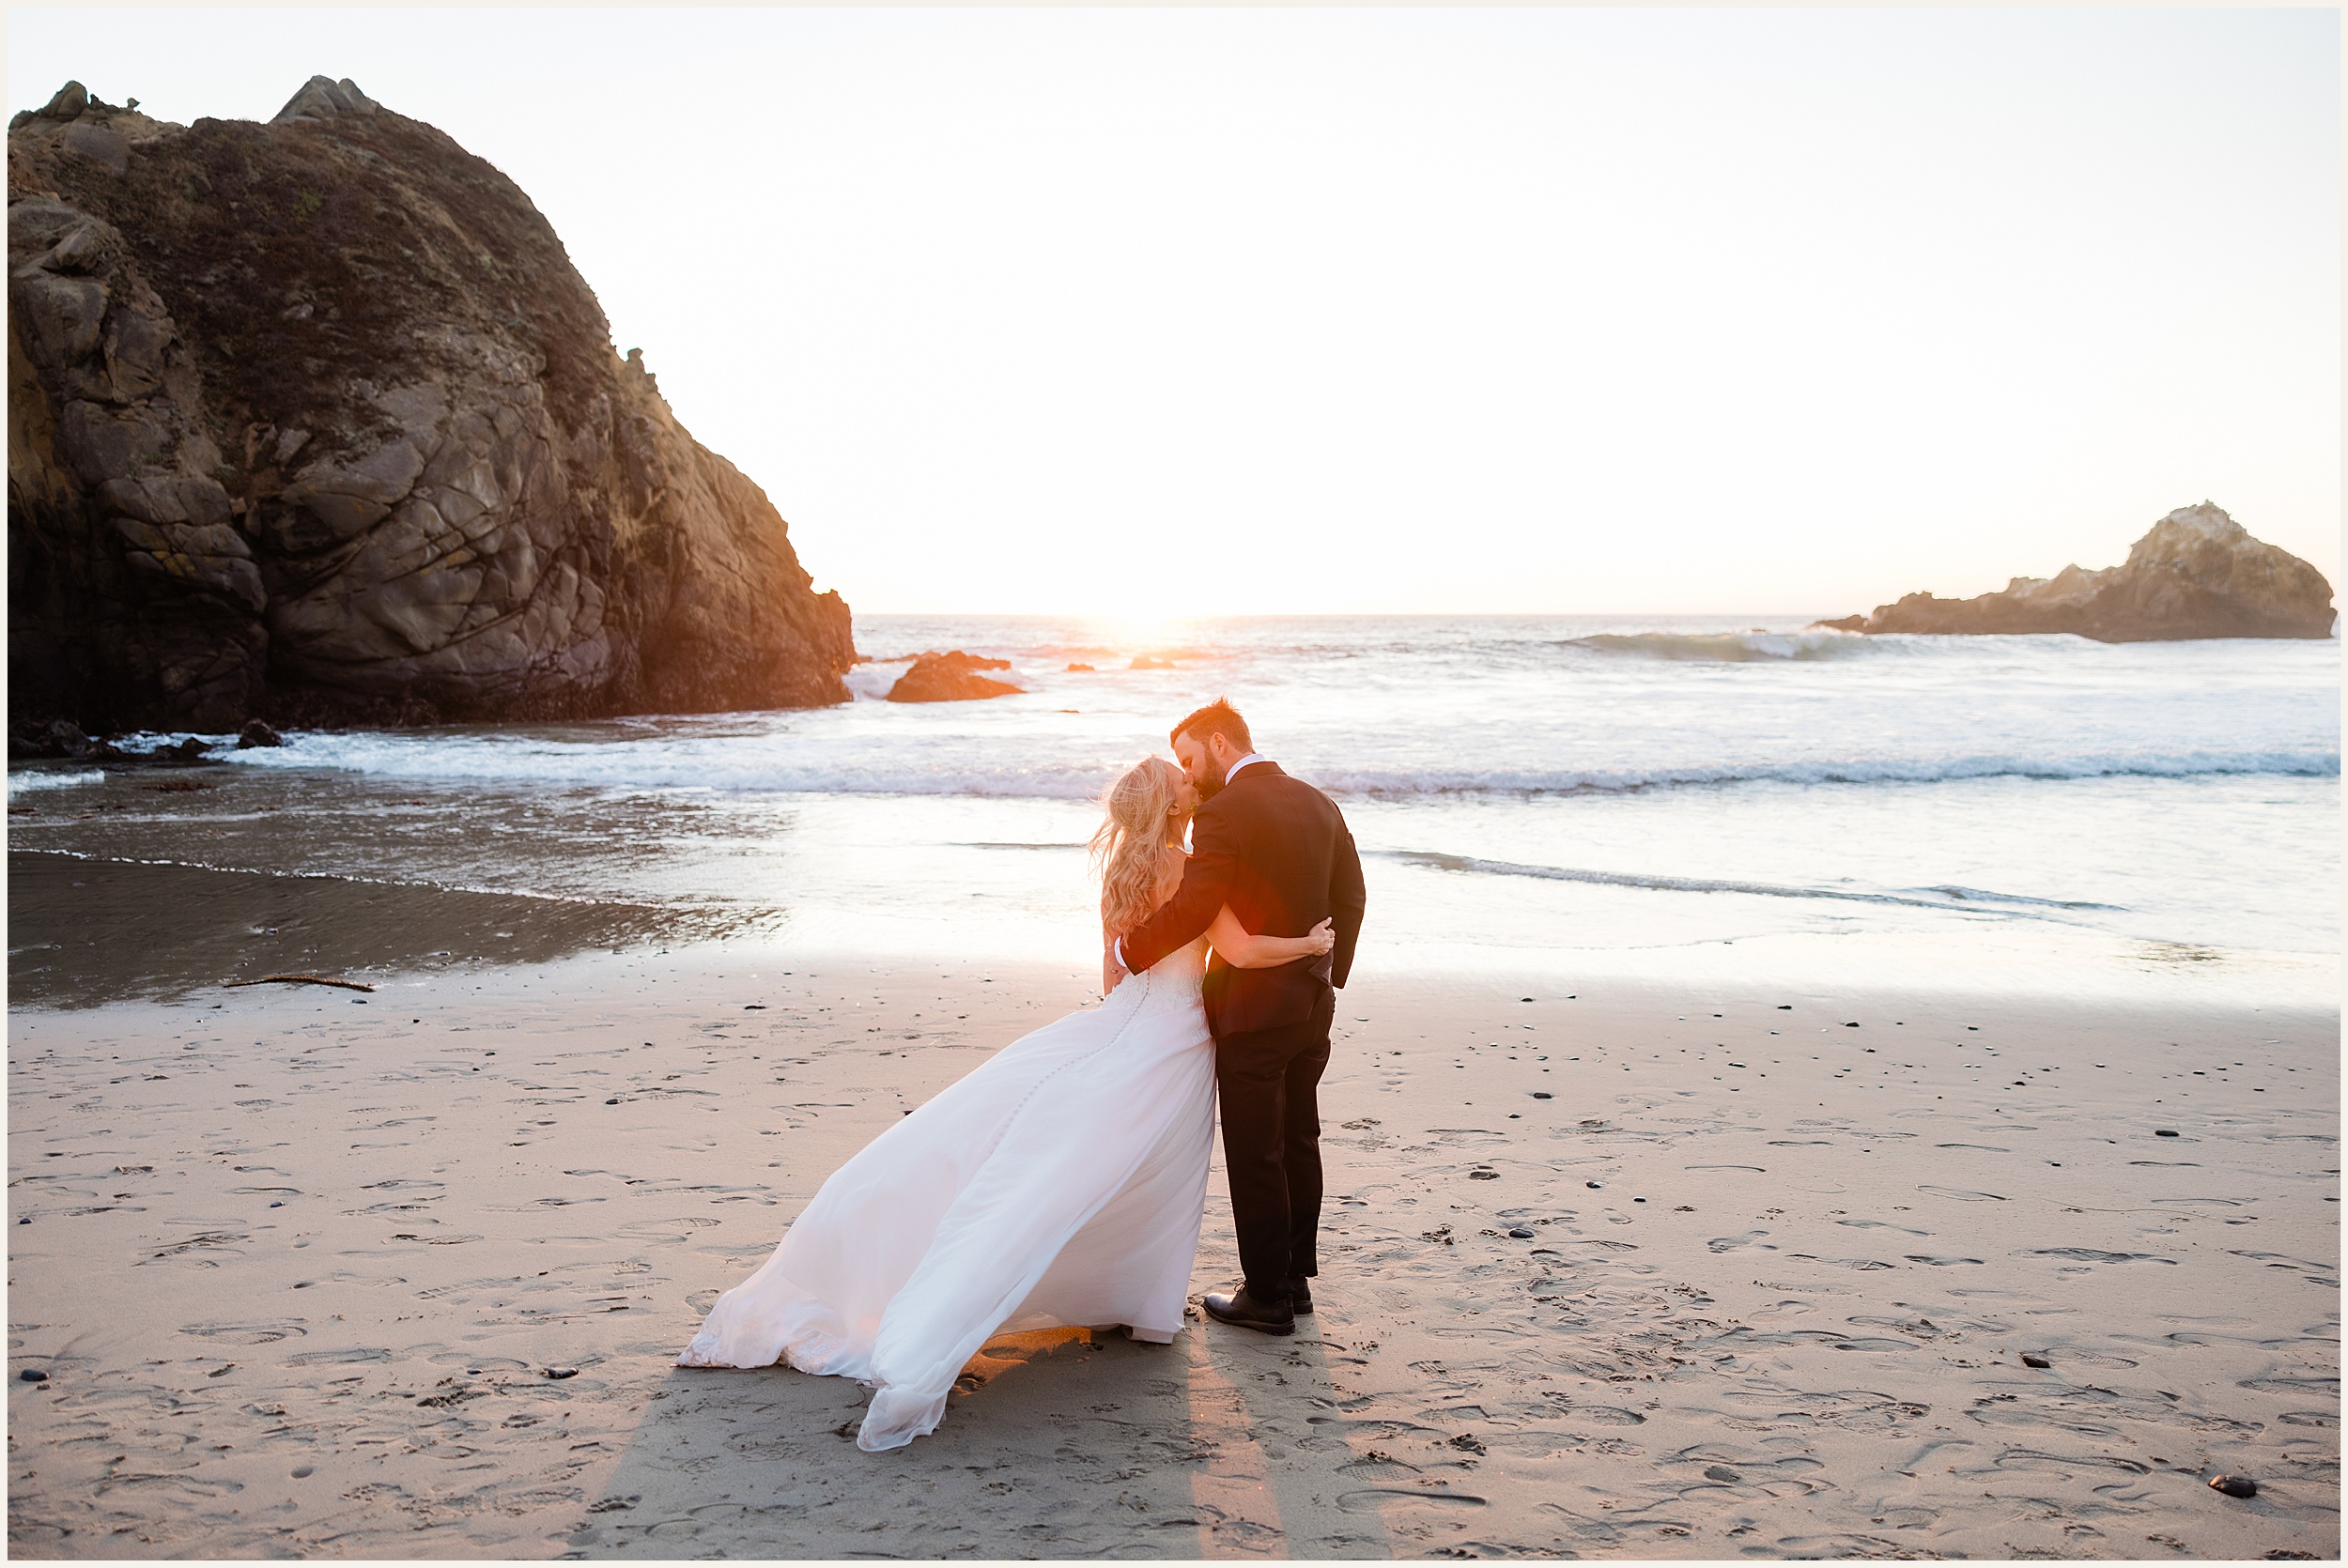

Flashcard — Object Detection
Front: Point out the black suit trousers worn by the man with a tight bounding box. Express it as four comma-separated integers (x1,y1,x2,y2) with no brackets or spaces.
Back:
1214,993,1336,1300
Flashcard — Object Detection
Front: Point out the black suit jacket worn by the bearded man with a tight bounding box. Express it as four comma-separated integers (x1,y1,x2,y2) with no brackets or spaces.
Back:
1125,763,1365,1040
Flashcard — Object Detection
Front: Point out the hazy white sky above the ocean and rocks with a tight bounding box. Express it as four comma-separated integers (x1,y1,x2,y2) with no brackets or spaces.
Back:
8,9,2341,615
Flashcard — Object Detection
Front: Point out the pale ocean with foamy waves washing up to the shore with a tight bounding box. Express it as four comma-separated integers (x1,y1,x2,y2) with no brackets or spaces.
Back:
9,615,2341,1005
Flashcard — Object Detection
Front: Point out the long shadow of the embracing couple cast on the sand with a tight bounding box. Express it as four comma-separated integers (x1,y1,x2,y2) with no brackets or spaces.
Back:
568,1327,1393,1559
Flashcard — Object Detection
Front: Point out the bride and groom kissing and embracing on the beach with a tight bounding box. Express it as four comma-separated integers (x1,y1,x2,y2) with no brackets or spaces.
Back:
679,702,1362,1453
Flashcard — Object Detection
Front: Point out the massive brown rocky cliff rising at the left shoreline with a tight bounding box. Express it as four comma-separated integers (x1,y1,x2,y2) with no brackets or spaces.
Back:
8,78,855,730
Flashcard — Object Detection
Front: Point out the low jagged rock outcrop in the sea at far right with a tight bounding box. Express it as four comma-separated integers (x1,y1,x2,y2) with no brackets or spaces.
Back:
1817,500,2334,643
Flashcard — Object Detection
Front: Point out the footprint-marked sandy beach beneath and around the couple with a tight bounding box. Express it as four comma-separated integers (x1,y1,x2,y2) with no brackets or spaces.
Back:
9,857,2339,1559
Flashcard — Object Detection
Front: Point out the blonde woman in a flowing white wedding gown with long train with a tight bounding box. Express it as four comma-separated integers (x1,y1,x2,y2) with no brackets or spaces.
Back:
679,759,1334,1453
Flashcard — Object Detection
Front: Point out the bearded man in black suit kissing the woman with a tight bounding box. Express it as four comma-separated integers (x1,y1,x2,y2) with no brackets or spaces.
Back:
1116,702,1362,1333
